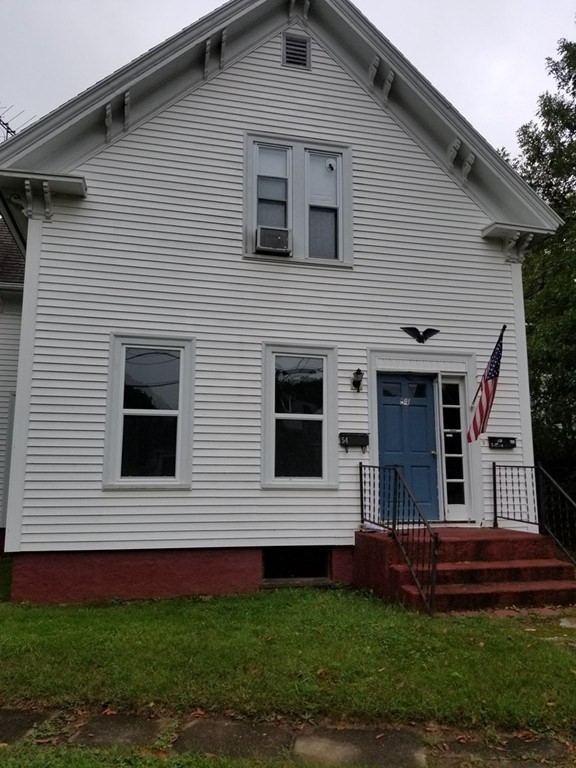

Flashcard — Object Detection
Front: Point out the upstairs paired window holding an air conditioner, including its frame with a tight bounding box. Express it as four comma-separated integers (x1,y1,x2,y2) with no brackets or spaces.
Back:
247,139,352,265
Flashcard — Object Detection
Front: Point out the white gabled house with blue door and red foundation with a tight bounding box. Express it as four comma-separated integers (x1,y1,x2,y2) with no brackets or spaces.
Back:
0,0,560,601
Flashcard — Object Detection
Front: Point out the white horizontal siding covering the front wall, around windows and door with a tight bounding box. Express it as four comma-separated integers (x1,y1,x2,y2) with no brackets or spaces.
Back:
7,28,524,551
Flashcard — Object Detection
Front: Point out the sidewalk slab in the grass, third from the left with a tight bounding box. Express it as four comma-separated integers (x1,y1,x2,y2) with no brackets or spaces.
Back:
172,718,293,757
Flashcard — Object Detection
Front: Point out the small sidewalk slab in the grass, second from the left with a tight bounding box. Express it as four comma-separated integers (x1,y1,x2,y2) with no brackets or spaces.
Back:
70,715,163,747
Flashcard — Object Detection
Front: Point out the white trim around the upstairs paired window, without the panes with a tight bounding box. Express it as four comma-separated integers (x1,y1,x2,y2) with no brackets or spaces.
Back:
244,134,354,268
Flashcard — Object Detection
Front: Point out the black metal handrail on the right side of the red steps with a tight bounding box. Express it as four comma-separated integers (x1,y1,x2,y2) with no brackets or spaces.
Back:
492,463,576,565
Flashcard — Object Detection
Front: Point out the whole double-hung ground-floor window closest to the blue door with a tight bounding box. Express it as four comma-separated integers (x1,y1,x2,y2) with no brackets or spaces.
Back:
263,345,337,486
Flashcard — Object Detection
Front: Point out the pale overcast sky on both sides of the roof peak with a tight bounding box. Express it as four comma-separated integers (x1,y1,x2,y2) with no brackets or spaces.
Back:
0,0,576,154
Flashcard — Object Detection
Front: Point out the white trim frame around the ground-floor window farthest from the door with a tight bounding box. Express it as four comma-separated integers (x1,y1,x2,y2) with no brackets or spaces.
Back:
102,333,194,490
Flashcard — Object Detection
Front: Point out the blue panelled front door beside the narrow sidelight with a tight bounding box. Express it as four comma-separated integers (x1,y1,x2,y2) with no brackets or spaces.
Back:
378,373,438,520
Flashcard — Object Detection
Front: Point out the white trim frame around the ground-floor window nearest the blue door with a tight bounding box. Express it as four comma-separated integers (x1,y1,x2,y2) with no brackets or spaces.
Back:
261,343,338,490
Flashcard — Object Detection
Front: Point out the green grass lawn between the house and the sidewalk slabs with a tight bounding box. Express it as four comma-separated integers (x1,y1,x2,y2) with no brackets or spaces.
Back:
0,589,576,732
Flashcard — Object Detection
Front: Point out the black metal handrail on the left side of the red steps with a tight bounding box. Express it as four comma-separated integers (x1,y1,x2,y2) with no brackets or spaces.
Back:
360,462,439,613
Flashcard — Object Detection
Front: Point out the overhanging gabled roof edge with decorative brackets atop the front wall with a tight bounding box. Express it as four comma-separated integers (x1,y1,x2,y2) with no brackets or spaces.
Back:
0,0,561,240
